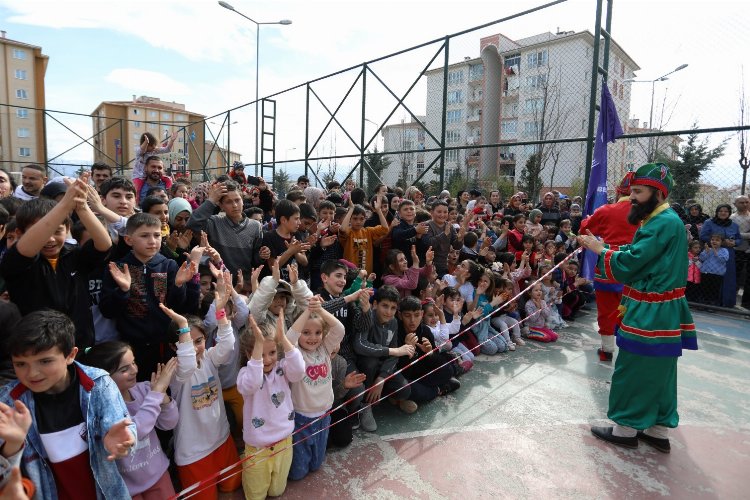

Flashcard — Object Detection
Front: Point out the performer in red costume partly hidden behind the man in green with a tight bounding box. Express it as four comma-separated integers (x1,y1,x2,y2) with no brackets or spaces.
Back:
579,172,638,361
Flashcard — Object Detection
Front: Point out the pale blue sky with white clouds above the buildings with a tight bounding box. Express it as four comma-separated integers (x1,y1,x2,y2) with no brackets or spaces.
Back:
0,0,750,185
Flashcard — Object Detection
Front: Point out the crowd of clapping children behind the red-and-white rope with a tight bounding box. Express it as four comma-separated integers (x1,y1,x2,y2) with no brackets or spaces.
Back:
0,162,604,499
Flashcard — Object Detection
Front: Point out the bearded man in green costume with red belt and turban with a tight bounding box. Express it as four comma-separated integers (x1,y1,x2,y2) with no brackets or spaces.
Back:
578,163,698,453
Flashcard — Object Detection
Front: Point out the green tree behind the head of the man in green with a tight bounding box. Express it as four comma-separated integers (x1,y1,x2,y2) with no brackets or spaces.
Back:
657,129,727,204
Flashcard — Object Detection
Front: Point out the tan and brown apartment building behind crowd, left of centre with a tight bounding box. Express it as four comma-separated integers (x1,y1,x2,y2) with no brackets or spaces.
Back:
91,95,206,179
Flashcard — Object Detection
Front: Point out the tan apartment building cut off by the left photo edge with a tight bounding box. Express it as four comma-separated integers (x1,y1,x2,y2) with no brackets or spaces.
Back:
0,31,49,172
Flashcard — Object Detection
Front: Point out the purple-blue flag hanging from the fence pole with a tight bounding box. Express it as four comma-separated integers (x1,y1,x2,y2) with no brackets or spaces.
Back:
581,82,623,279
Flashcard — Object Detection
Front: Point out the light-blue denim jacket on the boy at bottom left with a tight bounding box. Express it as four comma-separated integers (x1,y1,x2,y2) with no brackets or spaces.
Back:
0,362,137,500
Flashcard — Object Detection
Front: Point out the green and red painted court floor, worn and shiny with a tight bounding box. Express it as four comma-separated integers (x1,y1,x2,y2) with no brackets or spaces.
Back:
222,311,750,500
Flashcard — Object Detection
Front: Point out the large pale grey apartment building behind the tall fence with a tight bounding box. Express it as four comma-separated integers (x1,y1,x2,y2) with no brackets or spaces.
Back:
418,31,640,192
